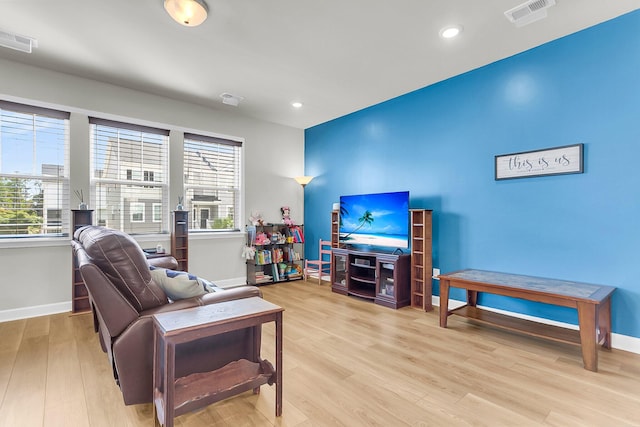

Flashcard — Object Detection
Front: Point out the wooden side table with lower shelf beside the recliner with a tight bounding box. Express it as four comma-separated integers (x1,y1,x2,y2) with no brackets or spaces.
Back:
153,297,284,427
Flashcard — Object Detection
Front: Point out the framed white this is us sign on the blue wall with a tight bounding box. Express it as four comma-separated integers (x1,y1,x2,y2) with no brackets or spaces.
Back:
496,144,584,181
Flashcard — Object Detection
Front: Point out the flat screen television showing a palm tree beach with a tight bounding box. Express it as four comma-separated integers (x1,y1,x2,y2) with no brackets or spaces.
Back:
340,191,409,249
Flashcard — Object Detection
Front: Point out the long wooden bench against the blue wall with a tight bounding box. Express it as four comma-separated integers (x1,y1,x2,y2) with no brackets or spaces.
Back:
438,270,615,372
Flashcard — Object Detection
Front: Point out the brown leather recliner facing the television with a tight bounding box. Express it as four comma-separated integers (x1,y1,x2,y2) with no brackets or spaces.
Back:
71,225,262,405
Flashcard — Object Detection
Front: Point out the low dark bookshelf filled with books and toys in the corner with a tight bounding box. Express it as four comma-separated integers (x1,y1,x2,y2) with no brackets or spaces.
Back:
247,224,304,286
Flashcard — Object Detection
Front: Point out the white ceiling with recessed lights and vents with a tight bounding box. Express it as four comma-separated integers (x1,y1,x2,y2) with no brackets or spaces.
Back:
0,0,640,128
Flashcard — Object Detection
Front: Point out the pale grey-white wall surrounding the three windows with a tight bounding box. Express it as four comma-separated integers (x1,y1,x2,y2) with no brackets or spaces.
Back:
0,59,304,321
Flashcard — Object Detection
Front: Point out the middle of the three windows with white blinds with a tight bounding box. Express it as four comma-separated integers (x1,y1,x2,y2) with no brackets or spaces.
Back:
89,117,169,234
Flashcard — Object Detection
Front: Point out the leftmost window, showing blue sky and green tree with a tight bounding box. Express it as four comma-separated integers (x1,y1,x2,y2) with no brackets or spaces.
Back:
0,101,70,238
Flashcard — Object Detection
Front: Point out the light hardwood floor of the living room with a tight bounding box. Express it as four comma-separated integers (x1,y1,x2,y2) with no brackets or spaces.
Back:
0,281,640,427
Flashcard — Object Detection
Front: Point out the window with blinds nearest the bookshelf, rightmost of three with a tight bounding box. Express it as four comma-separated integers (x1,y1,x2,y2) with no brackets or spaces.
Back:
184,133,242,231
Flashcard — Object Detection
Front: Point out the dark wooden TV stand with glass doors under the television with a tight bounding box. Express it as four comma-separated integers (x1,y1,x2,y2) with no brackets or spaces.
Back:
331,248,411,309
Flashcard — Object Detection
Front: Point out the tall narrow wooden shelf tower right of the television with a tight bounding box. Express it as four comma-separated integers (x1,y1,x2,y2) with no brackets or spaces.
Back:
410,209,433,311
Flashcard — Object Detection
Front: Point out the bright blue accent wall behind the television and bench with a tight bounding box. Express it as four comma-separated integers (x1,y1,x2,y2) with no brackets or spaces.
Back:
305,10,640,337
